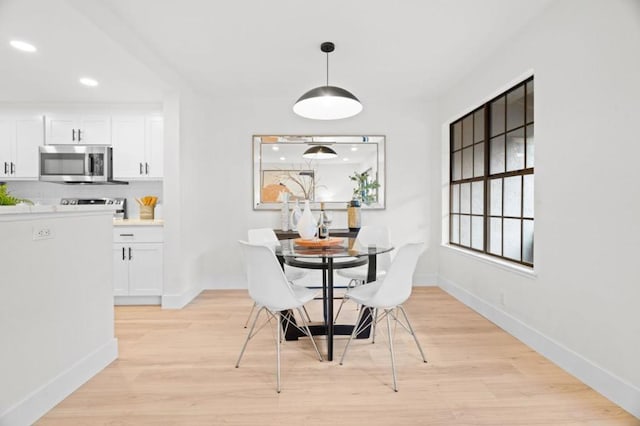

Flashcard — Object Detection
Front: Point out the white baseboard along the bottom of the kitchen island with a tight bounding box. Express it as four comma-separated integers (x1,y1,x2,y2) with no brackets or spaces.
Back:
0,338,118,426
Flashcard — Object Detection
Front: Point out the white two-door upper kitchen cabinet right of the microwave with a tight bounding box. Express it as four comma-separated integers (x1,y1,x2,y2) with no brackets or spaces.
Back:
112,116,164,180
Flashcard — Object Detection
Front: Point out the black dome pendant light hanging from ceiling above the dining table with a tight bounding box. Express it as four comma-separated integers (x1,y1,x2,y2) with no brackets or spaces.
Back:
293,41,362,120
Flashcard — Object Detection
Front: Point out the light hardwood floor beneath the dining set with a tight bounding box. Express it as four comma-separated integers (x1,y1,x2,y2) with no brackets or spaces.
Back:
38,287,640,426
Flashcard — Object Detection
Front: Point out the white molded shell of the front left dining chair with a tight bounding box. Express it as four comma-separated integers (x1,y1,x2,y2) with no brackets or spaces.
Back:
240,241,302,311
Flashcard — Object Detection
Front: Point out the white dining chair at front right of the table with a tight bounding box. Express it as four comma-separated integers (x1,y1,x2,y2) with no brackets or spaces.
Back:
340,243,427,392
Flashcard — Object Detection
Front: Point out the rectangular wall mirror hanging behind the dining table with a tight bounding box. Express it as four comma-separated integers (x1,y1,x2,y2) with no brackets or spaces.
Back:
253,135,385,210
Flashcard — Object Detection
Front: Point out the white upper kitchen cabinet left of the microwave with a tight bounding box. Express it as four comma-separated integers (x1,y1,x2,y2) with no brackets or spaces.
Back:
0,117,44,180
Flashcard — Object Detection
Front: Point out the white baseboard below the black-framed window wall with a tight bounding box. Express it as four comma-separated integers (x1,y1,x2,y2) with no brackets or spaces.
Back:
438,277,640,418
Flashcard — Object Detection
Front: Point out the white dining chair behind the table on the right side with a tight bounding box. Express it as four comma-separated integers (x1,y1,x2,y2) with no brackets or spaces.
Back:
335,226,391,320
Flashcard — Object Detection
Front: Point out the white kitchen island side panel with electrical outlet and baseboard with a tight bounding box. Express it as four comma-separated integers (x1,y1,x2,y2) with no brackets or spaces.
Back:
0,208,117,425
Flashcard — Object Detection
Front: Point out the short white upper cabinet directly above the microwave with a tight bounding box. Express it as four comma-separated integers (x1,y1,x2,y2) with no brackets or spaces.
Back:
45,115,111,145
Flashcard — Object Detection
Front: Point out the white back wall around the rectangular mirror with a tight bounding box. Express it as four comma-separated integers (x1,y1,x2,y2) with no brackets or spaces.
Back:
170,94,435,288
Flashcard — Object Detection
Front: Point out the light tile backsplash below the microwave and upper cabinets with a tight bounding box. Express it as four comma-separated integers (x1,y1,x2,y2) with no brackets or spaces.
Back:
7,181,163,219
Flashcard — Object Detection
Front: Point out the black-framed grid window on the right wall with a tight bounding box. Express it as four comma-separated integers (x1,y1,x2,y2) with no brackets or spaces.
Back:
449,77,535,266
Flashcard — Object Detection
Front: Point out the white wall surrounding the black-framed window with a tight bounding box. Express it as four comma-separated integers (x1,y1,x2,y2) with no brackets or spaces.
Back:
432,0,640,416
